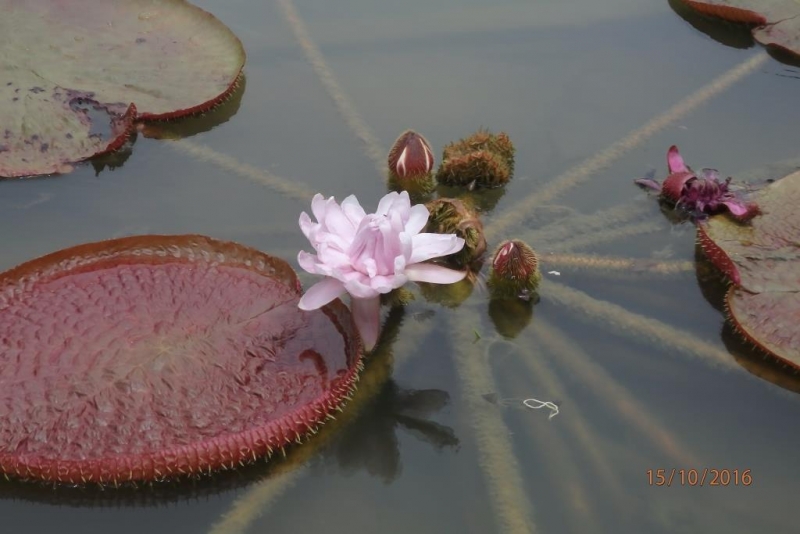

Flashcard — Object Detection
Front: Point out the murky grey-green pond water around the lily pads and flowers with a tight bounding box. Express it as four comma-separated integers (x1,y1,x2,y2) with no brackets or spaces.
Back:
0,0,800,534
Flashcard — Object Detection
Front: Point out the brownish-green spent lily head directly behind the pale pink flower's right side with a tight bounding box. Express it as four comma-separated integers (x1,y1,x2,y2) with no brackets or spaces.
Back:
425,198,486,267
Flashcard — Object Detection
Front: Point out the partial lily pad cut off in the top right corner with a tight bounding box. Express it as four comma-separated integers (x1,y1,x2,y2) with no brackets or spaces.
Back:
682,0,800,56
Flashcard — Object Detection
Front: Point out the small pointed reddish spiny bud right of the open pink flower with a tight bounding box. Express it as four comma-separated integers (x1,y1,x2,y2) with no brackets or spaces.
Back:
488,239,542,300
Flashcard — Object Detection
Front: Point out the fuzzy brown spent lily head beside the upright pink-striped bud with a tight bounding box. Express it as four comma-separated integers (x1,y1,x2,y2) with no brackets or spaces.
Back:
436,130,515,187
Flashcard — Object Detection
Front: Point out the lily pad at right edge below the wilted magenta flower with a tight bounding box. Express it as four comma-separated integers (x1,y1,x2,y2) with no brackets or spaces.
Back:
698,172,800,368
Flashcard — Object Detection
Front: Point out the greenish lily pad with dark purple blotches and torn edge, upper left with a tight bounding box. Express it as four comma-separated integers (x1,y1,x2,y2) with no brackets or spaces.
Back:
0,0,245,177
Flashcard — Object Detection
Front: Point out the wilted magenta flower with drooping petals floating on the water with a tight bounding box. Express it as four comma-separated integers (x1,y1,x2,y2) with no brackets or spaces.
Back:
635,145,759,220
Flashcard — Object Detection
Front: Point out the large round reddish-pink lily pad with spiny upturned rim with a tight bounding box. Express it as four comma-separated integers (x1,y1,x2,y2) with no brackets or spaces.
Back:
0,235,362,484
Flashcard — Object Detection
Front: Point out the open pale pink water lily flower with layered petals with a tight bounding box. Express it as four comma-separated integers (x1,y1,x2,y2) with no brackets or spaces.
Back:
297,191,466,350
